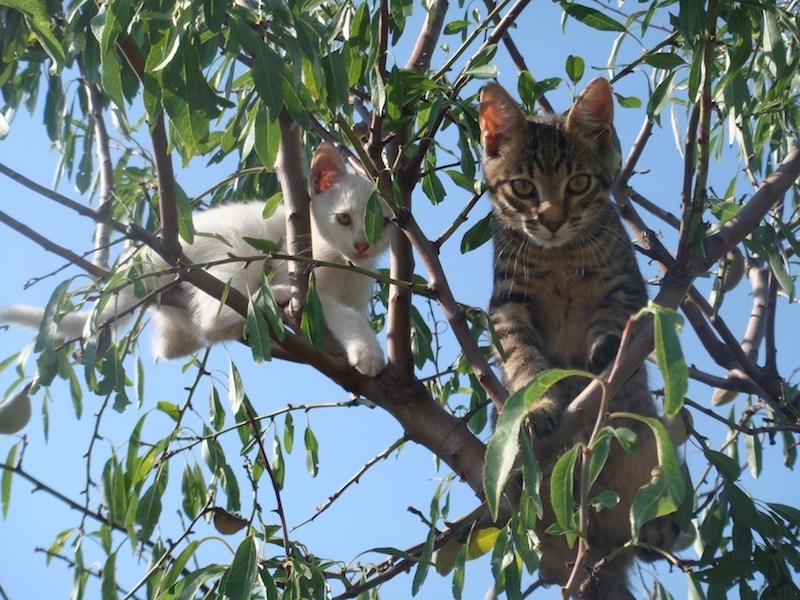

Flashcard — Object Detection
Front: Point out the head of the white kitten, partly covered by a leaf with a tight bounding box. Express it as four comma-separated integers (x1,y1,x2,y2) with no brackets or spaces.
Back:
309,142,392,265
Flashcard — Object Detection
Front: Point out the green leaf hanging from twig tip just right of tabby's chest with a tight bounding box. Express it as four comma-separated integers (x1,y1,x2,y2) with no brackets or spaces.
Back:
645,302,689,415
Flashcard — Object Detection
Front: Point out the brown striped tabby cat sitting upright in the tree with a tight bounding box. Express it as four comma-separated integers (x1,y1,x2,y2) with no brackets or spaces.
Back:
479,78,678,600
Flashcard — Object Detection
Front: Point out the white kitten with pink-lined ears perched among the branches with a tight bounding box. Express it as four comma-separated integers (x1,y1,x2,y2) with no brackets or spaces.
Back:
0,143,391,375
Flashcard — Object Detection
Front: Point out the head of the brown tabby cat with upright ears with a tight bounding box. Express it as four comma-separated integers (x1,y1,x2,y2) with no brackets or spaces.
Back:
479,78,616,248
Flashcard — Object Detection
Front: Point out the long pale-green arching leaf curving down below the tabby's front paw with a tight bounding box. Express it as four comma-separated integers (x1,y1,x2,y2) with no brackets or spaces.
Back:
483,369,594,519
